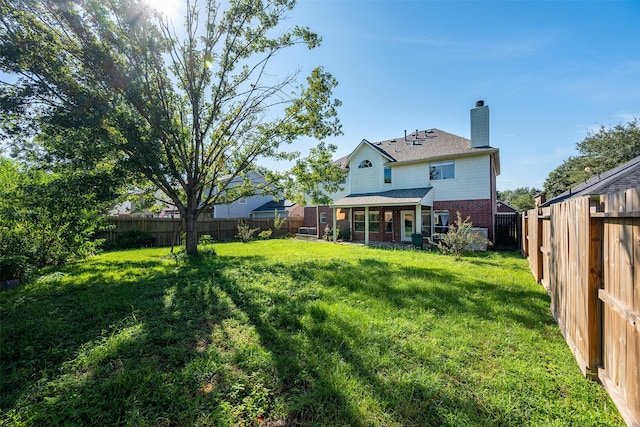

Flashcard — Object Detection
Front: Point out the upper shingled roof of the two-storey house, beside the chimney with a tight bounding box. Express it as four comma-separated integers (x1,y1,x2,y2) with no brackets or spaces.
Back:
344,128,499,170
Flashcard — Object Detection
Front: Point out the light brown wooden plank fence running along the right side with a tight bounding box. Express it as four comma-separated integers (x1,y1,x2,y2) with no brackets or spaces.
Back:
522,187,640,426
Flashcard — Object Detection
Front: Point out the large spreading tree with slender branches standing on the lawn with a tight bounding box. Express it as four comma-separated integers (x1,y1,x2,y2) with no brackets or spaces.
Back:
0,0,341,254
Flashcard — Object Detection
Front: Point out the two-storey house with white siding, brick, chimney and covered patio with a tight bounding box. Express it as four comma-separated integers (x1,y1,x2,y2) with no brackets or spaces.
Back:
305,101,500,244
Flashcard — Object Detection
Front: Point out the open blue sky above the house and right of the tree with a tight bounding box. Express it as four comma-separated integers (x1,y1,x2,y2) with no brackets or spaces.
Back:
278,0,640,190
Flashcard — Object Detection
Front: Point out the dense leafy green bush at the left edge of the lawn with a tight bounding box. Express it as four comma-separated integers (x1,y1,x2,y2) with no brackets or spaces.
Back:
0,158,110,267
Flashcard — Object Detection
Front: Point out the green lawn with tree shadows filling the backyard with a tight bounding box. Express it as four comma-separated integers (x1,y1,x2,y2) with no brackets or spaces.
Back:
0,240,623,427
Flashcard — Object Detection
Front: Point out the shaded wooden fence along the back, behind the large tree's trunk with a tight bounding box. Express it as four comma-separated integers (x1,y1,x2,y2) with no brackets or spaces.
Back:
105,216,304,246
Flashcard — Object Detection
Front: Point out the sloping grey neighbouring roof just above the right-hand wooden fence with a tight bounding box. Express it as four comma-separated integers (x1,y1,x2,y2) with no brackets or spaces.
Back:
543,156,640,206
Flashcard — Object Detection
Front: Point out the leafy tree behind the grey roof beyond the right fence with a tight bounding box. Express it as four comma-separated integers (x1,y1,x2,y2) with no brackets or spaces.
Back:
544,117,640,198
